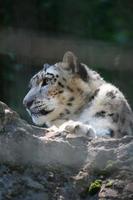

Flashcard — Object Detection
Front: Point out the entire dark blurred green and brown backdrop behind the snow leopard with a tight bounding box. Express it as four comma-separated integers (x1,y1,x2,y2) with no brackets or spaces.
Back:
0,0,133,120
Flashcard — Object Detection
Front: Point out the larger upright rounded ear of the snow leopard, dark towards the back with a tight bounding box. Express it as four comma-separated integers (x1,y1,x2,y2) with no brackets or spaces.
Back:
63,51,88,81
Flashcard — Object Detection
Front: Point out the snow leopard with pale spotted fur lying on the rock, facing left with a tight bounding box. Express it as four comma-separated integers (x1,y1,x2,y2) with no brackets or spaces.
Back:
23,52,133,137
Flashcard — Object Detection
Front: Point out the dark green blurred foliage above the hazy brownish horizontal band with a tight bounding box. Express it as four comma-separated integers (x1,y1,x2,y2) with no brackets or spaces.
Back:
0,0,133,44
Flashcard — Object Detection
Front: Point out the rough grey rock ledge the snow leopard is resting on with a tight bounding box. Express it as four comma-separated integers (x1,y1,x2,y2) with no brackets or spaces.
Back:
0,102,133,200
